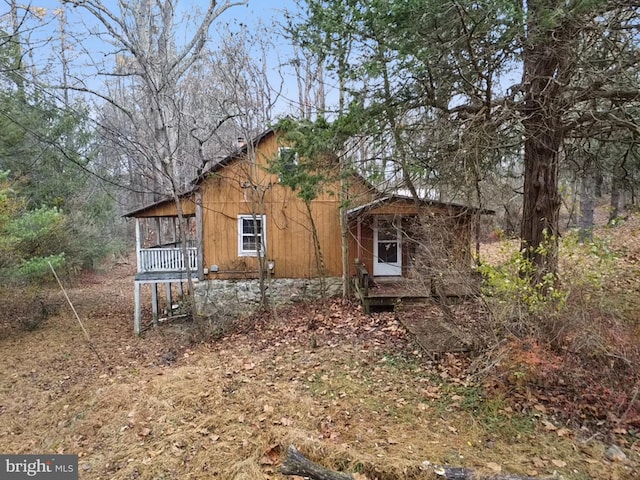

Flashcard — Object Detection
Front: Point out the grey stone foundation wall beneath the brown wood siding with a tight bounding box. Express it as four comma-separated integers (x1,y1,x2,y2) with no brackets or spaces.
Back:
194,277,342,316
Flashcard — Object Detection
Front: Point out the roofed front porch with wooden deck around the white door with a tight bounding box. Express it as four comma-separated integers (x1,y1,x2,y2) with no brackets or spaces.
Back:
348,195,492,313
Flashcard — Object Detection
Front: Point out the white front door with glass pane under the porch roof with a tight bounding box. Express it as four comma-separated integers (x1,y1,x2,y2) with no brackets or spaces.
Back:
373,217,402,277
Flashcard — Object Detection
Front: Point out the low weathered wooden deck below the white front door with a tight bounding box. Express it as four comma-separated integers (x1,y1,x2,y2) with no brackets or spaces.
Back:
354,264,479,314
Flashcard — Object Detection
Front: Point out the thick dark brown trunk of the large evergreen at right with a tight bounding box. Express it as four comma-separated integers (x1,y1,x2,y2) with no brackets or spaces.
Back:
521,0,573,283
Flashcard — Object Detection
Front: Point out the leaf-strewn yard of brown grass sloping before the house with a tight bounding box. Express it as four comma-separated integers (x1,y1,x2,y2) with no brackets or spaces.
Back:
0,253,640,480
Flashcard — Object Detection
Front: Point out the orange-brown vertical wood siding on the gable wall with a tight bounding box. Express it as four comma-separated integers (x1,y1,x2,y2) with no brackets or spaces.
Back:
200,134,360,279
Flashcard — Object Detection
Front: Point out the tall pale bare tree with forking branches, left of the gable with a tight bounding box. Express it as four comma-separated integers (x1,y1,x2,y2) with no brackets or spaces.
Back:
55,0,246,306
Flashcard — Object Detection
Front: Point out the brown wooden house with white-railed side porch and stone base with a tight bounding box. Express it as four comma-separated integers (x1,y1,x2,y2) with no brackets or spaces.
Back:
126,130,488,333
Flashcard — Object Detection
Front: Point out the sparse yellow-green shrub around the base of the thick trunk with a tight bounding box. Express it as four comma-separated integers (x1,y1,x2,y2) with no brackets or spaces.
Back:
477,232,616,345
